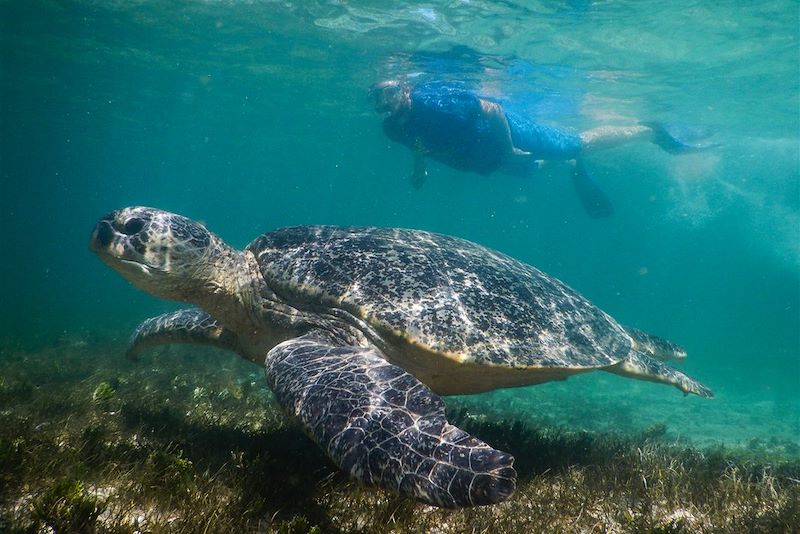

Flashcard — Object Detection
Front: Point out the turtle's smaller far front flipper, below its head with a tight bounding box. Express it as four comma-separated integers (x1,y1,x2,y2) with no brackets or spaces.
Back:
125,308,239,359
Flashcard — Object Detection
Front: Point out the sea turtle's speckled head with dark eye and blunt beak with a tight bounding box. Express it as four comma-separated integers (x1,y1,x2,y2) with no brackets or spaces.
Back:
89,206,235,302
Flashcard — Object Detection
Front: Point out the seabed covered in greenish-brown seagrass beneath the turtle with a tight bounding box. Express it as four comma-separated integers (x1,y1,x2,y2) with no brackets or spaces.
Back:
0,342,800,534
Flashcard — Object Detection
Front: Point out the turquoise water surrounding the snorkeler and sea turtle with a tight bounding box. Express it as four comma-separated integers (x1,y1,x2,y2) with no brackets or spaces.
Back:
0,0,800,448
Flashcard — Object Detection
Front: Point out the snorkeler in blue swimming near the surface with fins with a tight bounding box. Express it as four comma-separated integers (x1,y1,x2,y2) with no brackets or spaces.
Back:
370,80,711,217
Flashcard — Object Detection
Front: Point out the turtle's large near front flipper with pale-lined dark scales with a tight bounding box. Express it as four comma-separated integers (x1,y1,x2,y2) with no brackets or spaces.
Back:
266,331,516,508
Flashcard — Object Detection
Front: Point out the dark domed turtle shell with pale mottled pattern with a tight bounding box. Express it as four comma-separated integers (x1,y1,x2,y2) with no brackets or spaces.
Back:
248,226,633,369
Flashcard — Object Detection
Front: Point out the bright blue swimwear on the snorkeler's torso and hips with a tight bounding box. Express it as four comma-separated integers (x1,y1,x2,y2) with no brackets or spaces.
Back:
383,82,581,174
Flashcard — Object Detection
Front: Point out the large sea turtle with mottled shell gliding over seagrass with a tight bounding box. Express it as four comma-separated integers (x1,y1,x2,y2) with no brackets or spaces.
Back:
90,207,712,507
